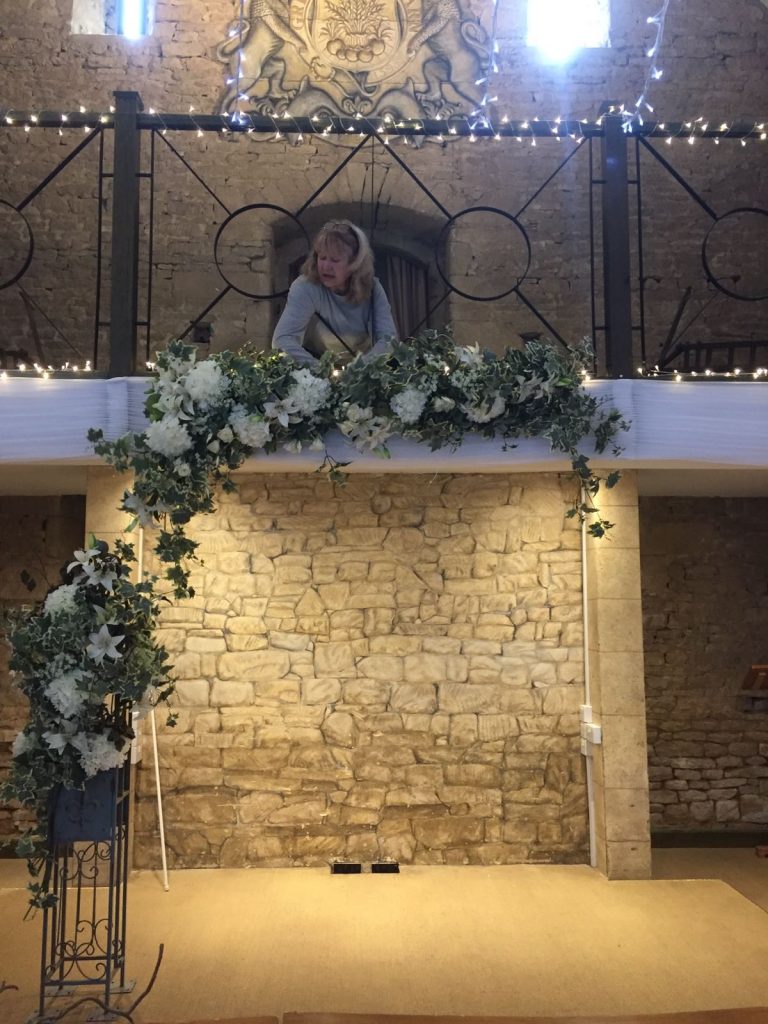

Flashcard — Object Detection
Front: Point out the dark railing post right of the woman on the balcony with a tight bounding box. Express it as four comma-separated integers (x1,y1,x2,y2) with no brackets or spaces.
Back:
602,115,635,377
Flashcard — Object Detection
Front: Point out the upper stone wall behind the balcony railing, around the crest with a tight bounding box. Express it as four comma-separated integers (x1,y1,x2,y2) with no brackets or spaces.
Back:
0,0,768,362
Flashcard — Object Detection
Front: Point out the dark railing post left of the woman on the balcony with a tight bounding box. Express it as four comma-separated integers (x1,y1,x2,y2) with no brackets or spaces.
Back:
109,92,143,377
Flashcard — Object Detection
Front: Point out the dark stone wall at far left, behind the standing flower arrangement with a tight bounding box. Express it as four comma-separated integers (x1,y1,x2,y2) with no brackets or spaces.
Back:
0,496,85,844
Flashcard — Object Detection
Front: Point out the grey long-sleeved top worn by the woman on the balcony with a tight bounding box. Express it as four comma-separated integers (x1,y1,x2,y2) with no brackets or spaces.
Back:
272,276,397,364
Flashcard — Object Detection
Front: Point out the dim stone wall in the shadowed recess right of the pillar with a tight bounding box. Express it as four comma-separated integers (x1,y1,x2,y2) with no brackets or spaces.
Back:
640,498,768,830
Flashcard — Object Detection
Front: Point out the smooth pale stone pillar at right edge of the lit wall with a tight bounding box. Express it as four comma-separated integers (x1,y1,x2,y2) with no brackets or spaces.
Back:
587,471,650,879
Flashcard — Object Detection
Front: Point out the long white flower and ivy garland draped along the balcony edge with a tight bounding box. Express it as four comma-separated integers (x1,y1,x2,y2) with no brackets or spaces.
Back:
88,331,628,597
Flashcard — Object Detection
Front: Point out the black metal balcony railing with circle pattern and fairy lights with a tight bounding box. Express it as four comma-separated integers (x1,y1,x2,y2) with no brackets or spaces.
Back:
0,92,768,377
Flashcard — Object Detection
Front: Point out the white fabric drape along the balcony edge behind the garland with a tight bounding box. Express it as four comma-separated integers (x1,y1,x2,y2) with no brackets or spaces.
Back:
0,377,768,473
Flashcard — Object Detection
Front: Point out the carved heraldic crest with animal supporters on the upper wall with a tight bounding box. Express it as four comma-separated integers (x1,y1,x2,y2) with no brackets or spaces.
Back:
216,0,488,118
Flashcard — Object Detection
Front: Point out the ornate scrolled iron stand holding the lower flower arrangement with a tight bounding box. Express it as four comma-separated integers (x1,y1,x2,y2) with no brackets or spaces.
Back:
40,759,133,1017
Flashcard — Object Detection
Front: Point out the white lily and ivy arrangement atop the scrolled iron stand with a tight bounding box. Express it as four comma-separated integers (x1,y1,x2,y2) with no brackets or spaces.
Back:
0,541,173,906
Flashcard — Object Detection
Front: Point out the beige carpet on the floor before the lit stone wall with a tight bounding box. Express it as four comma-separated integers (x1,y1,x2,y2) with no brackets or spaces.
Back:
0,858,768,1024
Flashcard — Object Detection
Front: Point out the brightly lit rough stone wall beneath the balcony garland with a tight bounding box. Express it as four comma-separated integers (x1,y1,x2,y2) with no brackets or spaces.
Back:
135,475,587,866
